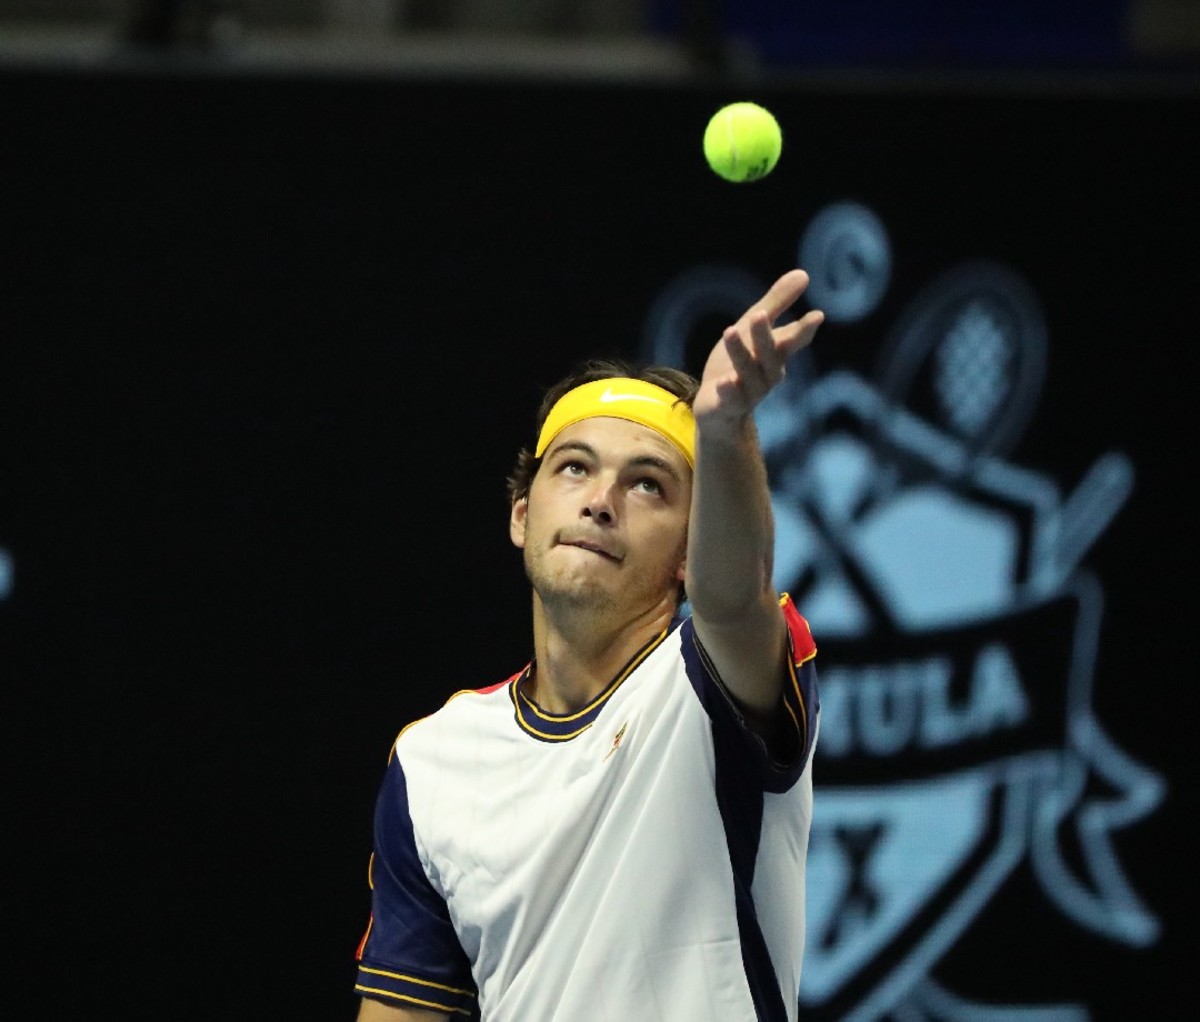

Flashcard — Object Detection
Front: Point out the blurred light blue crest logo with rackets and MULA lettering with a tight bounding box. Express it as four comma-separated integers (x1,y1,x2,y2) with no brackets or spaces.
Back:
642,203,1165,1022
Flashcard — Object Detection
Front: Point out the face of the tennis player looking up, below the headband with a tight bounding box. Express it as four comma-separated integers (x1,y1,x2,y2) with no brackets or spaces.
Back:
510,416,691,614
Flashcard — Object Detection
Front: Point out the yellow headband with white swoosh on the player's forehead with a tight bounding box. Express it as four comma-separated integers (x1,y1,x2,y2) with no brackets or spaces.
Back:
534,377,696,468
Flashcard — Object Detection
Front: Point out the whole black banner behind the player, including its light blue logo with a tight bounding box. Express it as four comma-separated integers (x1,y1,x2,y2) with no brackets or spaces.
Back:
0,68,1200,1022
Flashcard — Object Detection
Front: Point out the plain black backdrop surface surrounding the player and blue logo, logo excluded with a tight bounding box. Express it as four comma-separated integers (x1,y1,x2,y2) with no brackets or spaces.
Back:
0,71,1200,1022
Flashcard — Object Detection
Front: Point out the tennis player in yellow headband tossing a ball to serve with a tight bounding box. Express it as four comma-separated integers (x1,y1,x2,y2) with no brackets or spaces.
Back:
355,270,823,1022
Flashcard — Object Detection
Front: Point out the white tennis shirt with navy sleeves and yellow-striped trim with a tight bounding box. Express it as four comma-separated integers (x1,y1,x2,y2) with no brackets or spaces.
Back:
355,596,818,1022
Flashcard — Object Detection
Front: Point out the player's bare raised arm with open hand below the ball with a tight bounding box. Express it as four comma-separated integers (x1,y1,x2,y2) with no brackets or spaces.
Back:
686,270,824,727
